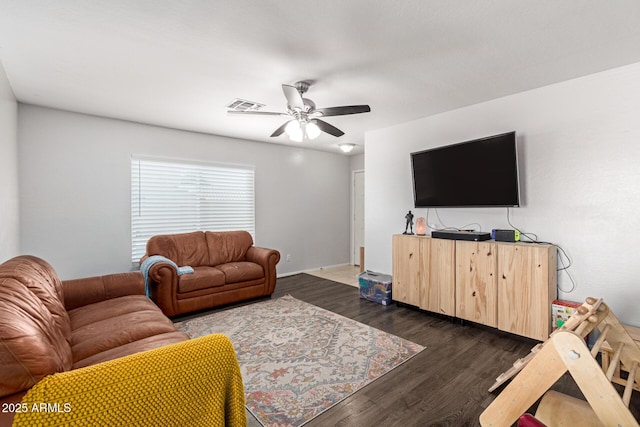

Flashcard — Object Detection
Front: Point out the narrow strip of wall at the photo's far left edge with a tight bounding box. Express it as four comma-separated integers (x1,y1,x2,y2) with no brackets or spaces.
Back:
0,59,20,263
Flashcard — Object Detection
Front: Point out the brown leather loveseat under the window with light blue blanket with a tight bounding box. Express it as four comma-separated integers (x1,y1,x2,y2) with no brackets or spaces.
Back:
140,231,280,316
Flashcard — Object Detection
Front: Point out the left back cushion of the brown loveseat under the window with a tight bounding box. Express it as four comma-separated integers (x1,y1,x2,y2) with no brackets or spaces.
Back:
146,231,210,267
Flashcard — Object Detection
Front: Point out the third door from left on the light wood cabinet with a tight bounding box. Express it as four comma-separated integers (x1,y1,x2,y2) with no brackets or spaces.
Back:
456,241,498,328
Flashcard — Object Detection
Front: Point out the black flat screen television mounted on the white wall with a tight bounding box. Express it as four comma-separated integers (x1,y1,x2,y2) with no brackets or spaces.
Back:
411,132,520,208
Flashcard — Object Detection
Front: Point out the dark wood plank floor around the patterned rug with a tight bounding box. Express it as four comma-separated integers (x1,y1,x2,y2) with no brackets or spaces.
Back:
178,274,640,427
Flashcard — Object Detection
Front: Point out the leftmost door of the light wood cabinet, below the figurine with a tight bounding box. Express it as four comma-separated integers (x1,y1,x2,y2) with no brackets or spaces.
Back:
391,235,424,306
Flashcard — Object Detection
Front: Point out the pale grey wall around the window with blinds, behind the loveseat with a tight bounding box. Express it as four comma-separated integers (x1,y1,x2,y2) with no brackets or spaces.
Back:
18,104,350,279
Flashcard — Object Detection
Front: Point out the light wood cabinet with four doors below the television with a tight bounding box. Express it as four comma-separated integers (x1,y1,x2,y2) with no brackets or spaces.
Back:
392,235,557,341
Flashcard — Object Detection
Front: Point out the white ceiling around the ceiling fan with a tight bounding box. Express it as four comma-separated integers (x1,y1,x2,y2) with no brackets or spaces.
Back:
0,0,640,153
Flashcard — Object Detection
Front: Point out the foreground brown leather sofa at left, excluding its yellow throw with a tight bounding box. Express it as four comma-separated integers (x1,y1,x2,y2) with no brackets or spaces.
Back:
0,256,188,426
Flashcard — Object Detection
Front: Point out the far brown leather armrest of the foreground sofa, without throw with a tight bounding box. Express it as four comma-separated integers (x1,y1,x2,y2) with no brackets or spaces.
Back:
62,271,144,310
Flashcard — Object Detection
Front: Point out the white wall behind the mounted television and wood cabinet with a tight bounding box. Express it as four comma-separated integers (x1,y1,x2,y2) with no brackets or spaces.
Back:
365,63,640,326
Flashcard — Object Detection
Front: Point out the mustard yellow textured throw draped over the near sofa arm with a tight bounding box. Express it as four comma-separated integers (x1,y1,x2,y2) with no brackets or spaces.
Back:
13,334,247,427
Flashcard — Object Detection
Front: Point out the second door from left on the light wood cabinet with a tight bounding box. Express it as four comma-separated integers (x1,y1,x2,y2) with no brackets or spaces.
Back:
420,239,456,316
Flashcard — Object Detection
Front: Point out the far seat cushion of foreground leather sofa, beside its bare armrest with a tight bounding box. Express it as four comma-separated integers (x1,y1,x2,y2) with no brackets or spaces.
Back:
69,295,180,365
